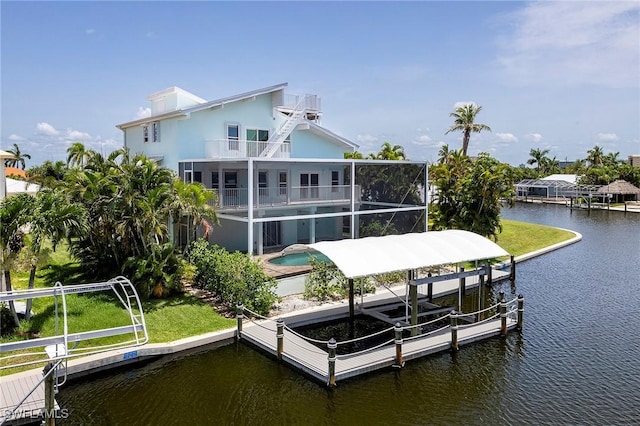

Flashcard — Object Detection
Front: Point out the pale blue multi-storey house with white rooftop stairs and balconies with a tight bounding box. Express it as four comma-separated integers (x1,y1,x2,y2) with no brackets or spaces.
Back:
117,83,427,254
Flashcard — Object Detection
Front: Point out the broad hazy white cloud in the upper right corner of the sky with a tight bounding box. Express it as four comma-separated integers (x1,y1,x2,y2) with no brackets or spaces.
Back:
498,1,640,88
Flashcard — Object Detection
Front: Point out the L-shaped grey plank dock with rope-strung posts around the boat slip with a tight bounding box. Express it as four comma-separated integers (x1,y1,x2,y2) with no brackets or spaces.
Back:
240,318,517,384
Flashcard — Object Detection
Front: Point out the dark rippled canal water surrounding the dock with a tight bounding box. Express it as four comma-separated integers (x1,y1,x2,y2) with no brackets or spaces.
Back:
57,204,640,425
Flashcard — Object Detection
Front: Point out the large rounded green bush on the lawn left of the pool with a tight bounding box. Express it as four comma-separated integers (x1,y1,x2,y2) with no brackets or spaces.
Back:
187,240,278,315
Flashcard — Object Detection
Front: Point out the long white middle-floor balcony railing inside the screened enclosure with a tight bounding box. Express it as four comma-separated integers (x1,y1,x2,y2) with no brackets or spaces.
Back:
209,185,360,210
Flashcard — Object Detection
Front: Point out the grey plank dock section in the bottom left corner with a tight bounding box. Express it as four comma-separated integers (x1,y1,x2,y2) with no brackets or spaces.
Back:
0,370,59,425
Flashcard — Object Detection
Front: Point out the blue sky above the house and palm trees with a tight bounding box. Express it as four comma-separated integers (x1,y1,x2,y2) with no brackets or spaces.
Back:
0,1,640,166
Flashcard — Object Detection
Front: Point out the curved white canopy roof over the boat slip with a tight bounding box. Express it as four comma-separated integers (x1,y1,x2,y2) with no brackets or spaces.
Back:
306,230,509,278
